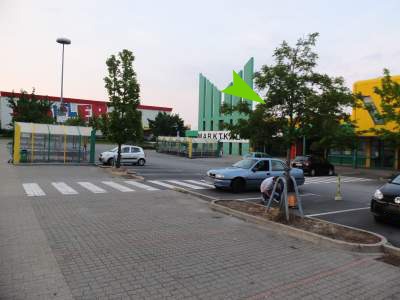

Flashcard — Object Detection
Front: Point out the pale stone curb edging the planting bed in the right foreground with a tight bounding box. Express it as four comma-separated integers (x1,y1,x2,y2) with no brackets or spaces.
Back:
209,200,388,255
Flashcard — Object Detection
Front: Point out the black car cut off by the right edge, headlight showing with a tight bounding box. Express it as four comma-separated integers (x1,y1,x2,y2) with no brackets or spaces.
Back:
371,174,400,221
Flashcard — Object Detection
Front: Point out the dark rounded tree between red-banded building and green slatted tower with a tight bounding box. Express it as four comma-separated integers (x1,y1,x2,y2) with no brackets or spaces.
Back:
148,112,186,137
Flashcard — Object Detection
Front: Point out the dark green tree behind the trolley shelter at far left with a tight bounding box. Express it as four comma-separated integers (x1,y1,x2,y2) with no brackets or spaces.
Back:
8,89,54,126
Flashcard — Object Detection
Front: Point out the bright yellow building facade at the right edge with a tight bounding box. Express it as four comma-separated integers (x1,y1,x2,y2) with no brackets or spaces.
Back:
352,76,400,169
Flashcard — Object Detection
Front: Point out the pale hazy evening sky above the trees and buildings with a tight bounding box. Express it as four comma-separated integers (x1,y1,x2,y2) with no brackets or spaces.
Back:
0,0,400,129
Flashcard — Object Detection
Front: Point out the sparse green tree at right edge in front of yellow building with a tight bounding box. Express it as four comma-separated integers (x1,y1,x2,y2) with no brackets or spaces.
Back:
365,69,400,147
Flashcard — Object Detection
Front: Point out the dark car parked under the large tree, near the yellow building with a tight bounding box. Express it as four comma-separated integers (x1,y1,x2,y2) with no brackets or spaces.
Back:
292,155,335,176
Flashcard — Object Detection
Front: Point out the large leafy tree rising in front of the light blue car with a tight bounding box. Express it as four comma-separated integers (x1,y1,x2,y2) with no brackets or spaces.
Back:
255,33,353,161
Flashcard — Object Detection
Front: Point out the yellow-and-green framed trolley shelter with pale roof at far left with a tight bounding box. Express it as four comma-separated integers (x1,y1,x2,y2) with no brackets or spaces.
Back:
12,122,96,164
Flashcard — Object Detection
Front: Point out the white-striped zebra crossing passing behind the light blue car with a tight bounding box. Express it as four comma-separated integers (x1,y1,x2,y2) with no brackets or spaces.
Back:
22,176,372,197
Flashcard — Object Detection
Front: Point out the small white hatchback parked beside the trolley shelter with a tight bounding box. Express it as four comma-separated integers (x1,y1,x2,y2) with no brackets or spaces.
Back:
99,145,146,166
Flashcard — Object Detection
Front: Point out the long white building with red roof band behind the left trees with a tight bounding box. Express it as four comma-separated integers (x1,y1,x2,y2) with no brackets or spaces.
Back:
0,91,172,129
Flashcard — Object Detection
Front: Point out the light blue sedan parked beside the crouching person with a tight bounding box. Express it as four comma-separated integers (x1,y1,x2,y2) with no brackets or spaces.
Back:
206,158,304,192
